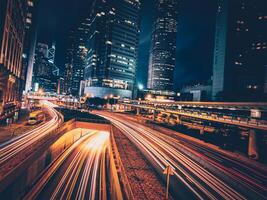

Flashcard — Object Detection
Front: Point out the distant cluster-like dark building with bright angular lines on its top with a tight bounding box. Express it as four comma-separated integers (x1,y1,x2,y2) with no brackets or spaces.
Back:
32,43,58,92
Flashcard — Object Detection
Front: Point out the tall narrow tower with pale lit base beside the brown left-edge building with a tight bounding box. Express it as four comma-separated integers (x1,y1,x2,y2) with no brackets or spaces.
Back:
22,0,38,92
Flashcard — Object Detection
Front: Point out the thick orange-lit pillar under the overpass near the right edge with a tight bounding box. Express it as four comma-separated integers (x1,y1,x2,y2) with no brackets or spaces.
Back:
248,129,259,160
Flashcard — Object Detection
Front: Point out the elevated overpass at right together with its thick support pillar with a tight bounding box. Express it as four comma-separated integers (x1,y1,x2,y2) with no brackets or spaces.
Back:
119,100,267,159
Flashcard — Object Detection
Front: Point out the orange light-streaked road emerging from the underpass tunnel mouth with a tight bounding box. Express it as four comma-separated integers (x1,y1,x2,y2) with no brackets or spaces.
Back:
24,130,110,200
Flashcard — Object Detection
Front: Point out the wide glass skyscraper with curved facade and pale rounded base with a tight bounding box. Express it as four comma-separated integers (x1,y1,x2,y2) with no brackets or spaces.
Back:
83,0,140,98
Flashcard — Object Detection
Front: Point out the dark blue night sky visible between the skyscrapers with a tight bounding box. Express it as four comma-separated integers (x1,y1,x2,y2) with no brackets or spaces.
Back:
38,0,216,88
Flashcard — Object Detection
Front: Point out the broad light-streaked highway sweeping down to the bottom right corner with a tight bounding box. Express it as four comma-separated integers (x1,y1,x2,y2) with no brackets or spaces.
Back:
97,112,267,199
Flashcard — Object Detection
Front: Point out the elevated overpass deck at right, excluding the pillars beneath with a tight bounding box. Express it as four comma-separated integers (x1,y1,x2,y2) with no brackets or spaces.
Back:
119,100,267,131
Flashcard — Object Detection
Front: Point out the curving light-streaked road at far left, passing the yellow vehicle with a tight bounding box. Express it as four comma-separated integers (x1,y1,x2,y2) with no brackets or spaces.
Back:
0,101,63,180
